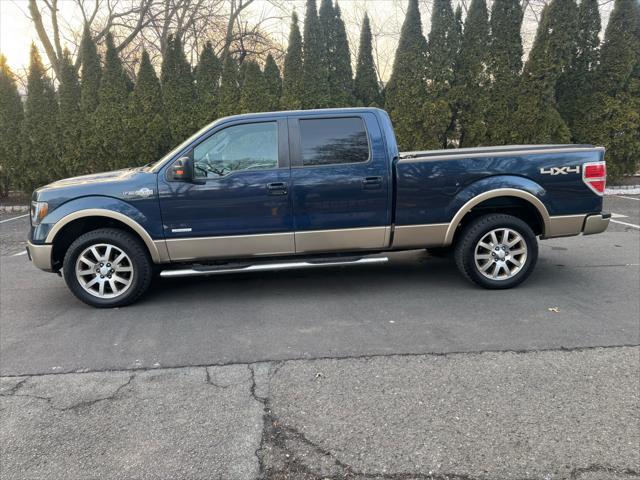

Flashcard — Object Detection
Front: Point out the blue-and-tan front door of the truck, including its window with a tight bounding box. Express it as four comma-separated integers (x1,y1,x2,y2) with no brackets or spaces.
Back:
158,119,295,261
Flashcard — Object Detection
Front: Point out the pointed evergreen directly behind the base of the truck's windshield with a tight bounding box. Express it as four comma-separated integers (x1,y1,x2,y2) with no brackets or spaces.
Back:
127,50,171,165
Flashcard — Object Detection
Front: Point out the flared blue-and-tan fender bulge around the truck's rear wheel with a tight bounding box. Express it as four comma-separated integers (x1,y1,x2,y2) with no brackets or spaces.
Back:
444,175,551,245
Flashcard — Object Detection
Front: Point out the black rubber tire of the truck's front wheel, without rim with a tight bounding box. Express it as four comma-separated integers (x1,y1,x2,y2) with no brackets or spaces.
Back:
62,228,153,308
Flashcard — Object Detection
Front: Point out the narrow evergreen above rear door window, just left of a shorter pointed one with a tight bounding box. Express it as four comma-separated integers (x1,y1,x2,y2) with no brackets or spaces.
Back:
325,0,354,107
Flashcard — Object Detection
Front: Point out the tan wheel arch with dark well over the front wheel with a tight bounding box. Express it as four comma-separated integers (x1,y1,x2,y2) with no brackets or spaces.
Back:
45,208,168,267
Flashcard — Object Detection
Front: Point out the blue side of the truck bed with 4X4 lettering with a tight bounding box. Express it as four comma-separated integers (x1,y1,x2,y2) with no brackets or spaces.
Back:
395,145,604,232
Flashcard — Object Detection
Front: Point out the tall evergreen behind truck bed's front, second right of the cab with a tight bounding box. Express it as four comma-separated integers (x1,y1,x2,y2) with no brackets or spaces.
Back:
424,0,459,148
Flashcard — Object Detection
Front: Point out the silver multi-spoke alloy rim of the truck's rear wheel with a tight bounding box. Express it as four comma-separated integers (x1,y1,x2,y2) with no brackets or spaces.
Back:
474,228,527,280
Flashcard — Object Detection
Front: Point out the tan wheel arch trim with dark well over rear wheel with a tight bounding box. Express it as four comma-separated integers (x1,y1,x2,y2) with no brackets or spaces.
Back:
444,188,551,245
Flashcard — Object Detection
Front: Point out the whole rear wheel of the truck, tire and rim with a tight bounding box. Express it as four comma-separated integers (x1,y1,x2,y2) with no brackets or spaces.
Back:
455,214,538,289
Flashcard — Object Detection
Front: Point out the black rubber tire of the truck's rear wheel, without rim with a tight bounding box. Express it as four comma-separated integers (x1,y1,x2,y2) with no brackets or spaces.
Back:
454,214,538,289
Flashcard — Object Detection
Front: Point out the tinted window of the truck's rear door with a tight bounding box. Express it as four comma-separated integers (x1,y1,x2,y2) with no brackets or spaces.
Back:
300,117,369,166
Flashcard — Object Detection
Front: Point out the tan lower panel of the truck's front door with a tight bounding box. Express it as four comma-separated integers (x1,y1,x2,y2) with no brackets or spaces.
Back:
166,232,295,262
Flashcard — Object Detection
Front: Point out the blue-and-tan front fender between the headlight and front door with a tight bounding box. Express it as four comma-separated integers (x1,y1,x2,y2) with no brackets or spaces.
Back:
33,196,168,263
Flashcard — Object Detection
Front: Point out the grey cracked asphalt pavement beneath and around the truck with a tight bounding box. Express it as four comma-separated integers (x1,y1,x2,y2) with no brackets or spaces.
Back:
0,196,640,480
